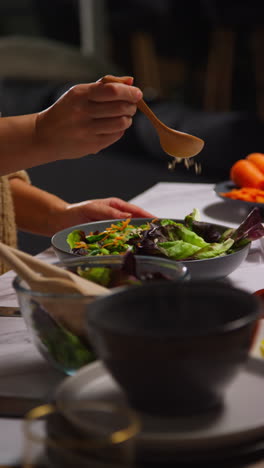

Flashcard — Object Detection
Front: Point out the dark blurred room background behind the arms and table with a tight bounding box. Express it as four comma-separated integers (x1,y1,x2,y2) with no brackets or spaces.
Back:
0,0,264,253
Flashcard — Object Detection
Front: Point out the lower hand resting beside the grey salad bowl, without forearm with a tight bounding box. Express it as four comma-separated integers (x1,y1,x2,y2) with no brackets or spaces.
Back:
56,197,154,229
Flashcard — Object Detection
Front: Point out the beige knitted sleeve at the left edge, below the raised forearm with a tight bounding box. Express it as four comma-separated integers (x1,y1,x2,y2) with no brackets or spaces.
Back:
0,171,30,274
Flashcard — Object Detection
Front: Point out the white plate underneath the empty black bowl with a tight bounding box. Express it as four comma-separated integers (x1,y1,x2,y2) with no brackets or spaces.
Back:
56,357,264,460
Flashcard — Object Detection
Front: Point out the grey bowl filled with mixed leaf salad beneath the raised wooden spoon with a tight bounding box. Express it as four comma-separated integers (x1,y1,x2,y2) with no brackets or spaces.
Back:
51,208,264,280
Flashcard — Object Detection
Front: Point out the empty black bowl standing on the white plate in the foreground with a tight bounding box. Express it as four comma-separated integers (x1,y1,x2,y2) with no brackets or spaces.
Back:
86,282,260,415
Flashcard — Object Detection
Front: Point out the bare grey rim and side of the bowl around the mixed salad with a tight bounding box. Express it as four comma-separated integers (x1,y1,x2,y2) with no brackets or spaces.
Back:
51,218,250,280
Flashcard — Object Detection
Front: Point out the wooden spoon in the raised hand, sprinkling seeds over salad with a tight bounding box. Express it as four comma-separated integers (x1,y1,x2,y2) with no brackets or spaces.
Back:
100,75,204,158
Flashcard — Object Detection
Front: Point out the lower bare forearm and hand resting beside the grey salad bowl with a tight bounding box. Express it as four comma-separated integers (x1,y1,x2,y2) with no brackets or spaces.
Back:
9,177,154,236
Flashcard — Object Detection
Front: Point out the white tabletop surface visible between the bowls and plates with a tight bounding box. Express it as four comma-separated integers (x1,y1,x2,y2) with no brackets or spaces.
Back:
0,183,264,466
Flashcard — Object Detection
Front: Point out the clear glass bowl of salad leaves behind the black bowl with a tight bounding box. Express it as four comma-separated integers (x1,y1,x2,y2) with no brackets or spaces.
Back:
13,256,189,375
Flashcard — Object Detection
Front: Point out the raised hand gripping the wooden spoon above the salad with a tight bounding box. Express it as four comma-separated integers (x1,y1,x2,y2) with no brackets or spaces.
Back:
35,77,142,160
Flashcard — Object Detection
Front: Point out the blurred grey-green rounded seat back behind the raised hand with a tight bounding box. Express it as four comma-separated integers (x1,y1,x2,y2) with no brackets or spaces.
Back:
0,36,117,81
